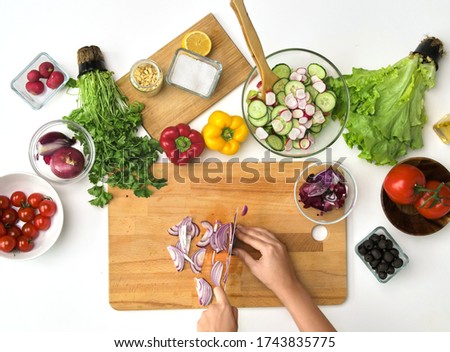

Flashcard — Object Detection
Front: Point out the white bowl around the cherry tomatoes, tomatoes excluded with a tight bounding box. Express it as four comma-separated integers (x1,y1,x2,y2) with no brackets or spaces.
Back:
0,172,64,261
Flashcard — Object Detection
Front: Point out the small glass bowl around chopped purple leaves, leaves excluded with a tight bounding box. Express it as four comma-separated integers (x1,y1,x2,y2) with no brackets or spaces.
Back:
294,161,358,225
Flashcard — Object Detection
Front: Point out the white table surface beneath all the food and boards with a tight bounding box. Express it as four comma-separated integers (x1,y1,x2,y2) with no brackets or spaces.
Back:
0,0,450,333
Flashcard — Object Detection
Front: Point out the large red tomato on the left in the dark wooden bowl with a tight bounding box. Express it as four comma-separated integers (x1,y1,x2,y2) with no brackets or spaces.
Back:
383,164,425,204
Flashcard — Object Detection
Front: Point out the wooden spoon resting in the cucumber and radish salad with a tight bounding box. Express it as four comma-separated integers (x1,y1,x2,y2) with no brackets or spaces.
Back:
230,0,279,100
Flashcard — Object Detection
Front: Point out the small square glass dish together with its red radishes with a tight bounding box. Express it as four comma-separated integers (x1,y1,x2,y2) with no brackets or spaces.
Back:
11,52,69,110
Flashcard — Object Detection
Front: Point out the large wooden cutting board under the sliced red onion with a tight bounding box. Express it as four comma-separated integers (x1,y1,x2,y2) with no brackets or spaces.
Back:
108,162,347,310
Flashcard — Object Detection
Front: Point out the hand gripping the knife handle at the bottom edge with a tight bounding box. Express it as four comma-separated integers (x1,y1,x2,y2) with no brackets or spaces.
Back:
197,286,238,332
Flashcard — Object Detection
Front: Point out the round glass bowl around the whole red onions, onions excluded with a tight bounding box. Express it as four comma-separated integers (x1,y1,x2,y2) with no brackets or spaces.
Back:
28,120,95,184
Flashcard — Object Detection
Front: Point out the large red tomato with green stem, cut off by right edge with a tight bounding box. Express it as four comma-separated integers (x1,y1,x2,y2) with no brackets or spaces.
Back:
414,180,450,220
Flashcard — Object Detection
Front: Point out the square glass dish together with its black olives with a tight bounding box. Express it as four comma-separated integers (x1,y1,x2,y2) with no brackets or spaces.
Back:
355,226,409,283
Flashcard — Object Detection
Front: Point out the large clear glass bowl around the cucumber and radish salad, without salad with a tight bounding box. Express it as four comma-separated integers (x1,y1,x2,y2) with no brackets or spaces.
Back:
241,48,350,158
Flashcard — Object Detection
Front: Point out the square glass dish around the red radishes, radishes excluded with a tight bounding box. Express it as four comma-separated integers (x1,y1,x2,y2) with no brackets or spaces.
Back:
11,52,69,110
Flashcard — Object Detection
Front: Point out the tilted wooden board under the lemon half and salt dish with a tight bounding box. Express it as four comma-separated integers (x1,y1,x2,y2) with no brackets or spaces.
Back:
117,14,252,138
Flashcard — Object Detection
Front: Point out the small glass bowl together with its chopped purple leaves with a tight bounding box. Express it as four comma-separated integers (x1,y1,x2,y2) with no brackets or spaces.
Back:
294,161,358,225
